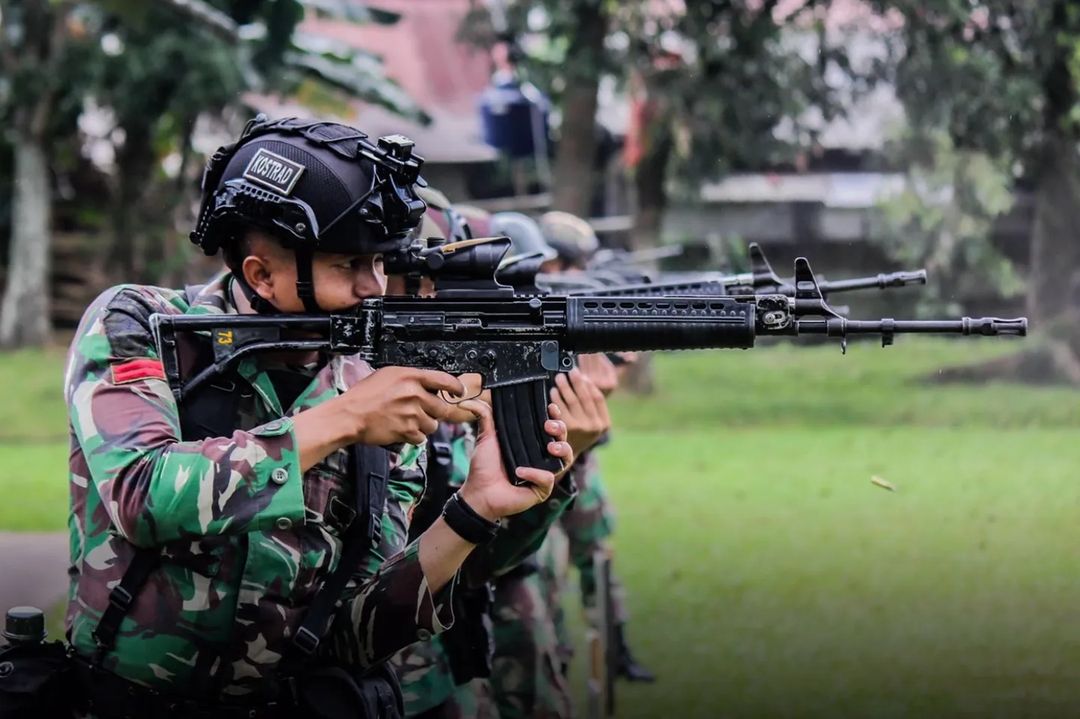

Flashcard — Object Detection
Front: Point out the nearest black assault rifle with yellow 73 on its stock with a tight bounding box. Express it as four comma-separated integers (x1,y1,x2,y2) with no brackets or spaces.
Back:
151,251,1027,477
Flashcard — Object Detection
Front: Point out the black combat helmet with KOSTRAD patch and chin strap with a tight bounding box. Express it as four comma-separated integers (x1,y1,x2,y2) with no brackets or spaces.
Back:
191,116,424,312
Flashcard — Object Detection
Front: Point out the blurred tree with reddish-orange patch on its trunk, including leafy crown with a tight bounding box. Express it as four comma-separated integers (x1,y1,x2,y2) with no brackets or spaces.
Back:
619,0,847,247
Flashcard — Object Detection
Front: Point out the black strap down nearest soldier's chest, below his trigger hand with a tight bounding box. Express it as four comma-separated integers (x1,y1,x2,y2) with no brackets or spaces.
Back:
293,445,390,656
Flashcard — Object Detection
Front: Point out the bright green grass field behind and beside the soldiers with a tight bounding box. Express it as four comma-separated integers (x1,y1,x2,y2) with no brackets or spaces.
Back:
0,338,1080,718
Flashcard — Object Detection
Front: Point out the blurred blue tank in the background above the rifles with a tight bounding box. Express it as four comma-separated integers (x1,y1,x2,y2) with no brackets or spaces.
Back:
478,80,550,159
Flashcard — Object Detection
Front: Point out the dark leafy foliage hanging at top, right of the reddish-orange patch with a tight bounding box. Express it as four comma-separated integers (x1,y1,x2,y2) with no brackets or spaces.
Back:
652,1,843,180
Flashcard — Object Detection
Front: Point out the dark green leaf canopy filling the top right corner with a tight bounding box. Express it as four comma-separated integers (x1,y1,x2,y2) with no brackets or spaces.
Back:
873,0,1080,161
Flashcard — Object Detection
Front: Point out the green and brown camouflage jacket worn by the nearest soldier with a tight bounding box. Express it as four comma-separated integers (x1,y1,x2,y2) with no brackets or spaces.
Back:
65,274,453,695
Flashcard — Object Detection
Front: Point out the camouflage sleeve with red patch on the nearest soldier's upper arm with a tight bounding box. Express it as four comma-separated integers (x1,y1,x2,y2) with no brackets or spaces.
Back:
66,290,305,546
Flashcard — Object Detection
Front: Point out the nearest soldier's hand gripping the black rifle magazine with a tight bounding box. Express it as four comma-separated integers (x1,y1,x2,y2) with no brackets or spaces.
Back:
458,399,573,521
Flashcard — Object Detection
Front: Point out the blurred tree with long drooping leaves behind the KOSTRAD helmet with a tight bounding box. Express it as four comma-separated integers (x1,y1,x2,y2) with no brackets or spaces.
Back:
96,0,427,281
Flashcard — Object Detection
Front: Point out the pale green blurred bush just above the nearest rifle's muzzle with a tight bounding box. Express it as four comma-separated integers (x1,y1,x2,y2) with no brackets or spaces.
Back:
879,132,1024,314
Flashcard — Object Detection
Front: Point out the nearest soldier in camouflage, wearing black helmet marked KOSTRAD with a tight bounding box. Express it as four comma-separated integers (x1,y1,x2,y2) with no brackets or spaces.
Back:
65,114,572,717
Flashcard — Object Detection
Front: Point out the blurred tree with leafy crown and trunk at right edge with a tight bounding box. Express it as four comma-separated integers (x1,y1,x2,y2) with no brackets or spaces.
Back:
874,0,1080,357
